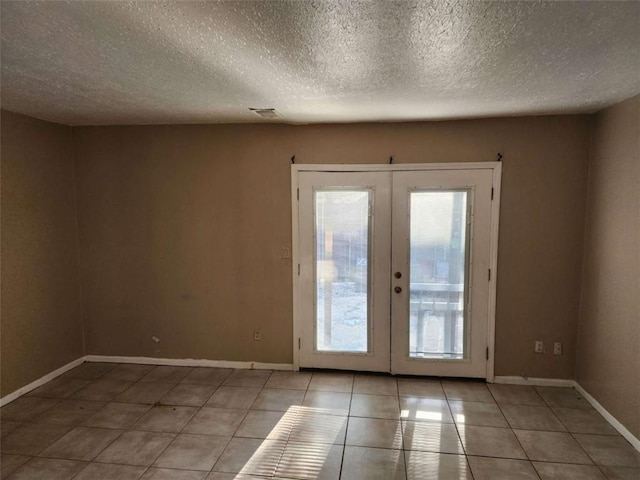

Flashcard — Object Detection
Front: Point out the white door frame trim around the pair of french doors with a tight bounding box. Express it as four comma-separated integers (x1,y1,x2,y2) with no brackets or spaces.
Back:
291,162,502,382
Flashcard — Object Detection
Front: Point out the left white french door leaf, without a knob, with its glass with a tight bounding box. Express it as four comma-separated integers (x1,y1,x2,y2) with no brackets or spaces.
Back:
296,172,391,372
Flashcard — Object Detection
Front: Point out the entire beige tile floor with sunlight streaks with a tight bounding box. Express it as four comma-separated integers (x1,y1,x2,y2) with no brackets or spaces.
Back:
0,363,640,480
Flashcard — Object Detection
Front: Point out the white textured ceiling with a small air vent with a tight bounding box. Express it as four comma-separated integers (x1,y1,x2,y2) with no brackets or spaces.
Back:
0,0,640,125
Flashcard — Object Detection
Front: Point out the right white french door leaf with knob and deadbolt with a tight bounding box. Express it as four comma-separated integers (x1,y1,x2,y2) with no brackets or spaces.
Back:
391,169,493,378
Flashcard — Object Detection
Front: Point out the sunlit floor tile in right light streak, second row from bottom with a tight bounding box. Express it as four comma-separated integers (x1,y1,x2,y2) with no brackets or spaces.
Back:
402,421,464,454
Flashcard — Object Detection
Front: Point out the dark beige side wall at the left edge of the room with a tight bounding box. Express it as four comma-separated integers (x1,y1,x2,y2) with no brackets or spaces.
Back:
0,111,83,396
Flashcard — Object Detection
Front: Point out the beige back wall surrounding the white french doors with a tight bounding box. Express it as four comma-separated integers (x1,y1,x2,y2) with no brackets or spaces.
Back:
74,116,589,378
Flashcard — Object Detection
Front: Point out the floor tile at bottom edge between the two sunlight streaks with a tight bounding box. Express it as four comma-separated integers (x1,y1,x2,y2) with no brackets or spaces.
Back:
342,446,404,480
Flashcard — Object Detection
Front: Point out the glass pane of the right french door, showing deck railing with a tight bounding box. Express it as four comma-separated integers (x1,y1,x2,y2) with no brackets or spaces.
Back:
409,189,470,360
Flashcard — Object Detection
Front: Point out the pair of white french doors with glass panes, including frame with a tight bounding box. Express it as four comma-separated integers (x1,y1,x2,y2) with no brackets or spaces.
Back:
292,163,500,378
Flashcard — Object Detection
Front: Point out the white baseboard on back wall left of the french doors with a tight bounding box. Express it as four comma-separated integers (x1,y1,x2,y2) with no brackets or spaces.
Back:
84,355,293,371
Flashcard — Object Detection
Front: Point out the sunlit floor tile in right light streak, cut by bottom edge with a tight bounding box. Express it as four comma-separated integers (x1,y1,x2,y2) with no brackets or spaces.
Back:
405,452,473,480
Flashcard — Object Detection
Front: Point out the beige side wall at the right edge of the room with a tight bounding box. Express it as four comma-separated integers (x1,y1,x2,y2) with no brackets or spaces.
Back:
577,96,640,437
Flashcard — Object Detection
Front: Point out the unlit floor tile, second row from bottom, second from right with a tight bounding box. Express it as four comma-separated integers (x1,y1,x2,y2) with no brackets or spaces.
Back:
514,430,591,464
